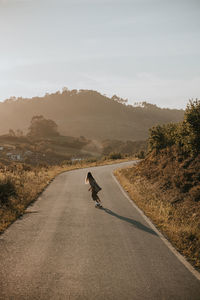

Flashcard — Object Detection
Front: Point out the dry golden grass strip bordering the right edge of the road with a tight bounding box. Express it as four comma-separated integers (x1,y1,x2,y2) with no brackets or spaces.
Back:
115,162,200,271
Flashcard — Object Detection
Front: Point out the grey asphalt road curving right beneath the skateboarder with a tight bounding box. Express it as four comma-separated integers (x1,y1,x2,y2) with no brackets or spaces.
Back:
0,165,200,300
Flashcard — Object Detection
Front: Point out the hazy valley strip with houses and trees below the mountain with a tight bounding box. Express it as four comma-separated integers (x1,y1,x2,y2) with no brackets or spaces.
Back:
0,135,146,165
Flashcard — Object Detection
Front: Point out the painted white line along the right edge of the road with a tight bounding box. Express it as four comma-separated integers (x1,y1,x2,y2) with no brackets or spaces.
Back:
112,173,200,280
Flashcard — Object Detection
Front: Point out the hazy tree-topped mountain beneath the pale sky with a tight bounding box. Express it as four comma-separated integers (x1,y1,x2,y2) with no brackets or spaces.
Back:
0,89,184,140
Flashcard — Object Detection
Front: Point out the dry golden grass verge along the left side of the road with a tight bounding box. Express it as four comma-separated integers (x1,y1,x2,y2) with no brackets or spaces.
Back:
0,157,133,233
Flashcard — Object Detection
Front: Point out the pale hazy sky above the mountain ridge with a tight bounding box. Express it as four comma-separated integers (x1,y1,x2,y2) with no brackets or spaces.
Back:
0,0,200,108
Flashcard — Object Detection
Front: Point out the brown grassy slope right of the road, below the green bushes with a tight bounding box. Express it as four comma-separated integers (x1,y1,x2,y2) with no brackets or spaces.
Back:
118,150,200,271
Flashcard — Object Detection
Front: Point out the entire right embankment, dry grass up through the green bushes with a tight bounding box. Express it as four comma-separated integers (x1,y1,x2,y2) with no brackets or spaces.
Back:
116,100,200,270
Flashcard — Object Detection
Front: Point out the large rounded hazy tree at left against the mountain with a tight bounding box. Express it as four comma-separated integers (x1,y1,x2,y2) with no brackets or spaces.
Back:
27,116,59,137
